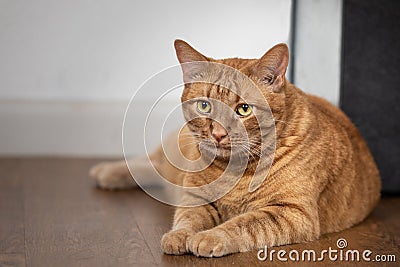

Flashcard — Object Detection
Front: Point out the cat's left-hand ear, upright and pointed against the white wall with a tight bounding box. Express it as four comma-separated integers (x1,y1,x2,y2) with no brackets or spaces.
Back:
174,39,209,83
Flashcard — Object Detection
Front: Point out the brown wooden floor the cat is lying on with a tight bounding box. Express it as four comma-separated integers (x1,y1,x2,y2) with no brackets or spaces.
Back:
0,158,400,266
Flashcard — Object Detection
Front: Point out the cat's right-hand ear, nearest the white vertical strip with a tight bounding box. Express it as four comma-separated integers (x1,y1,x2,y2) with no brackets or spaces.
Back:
252,44,289,92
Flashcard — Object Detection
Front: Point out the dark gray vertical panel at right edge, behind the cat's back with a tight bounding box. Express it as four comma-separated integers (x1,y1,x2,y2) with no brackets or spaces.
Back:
340,0,400,192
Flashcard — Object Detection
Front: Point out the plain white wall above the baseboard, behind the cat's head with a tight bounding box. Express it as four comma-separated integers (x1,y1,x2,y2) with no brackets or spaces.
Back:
0,0,290,101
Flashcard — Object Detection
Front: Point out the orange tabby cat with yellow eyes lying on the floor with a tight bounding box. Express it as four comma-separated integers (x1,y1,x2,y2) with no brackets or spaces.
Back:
91,40,381,257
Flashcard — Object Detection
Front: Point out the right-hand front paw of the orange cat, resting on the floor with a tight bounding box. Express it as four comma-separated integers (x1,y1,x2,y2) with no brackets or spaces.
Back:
188,229,234,257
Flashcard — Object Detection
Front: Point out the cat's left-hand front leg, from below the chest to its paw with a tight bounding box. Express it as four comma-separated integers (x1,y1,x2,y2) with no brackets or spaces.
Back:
161,204,220,255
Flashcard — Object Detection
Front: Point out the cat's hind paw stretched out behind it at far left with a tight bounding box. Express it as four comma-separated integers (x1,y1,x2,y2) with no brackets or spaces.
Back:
89,162,135,190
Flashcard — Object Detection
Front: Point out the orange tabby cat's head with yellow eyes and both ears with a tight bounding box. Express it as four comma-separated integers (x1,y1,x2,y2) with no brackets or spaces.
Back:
175,40,289,160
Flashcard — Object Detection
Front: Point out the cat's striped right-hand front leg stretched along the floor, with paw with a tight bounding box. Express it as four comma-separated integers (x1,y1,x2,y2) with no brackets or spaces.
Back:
187,204,320,257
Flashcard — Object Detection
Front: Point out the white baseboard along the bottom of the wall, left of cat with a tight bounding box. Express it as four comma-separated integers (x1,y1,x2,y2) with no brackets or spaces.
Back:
0,99,182,158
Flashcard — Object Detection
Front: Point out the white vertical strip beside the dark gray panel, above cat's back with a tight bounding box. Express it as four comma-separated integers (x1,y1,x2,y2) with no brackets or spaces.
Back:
293,0,342,105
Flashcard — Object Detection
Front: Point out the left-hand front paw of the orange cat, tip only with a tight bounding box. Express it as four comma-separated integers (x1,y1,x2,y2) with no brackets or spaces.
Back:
161,229,193,255
